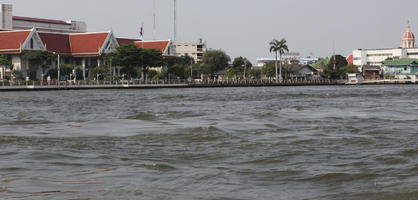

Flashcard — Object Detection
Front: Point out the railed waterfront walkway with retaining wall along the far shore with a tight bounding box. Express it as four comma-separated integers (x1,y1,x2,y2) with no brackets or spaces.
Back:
0,79,416,92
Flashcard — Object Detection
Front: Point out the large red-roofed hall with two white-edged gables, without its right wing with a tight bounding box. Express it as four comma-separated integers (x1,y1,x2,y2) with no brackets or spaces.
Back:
0,28,119,80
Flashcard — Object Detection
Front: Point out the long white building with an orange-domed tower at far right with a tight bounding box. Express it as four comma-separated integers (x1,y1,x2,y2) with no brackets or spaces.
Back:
353,24,418,67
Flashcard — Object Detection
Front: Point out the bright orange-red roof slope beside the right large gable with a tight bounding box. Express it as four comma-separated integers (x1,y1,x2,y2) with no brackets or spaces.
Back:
70,32,109,54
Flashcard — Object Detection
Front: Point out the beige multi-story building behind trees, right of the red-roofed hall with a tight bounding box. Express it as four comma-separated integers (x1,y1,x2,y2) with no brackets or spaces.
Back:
174,40,206,62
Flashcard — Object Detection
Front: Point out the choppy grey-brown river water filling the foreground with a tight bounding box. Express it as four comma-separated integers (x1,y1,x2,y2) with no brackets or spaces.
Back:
0,85,418,200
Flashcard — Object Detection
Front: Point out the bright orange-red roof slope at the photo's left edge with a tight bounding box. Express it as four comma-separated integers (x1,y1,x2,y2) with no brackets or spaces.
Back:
0,30,31,53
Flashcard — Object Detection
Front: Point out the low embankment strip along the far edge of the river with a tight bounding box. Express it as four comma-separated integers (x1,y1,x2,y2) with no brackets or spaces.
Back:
0,80,416,92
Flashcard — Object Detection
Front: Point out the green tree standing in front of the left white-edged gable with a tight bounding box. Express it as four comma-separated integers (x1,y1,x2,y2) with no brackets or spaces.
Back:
23,51,54,79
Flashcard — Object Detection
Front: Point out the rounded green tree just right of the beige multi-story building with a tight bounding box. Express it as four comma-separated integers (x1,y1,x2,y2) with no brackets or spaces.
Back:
200,50,231,74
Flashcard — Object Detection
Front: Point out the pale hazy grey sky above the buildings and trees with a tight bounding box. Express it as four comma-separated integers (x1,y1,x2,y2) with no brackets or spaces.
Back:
0,0,418,62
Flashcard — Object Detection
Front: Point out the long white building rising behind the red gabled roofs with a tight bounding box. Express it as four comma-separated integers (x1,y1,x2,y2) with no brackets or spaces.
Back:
0,4,87,33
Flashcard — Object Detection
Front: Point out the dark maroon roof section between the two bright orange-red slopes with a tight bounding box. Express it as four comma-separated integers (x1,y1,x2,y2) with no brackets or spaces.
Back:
39,33,71,53
